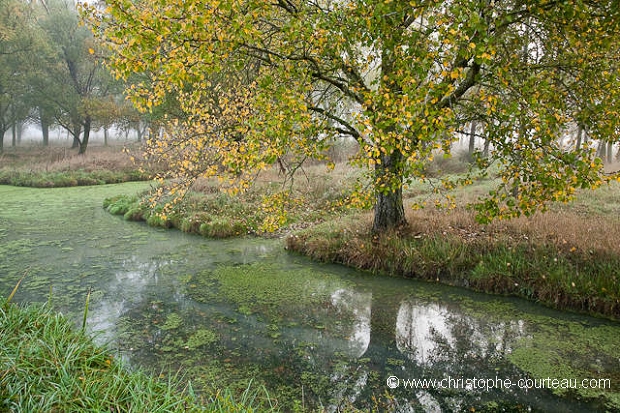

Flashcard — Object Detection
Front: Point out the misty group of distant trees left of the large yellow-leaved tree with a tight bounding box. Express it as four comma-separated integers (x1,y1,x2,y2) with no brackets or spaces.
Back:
0,0,149,153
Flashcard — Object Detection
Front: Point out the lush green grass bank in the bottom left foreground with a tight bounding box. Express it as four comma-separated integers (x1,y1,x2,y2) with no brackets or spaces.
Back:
0,298,275,412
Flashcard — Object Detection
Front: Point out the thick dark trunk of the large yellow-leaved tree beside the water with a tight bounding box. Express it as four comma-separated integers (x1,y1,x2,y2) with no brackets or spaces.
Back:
372,151,407,233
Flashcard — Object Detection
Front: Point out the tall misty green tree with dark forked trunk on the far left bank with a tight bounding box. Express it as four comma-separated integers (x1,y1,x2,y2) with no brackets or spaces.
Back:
31,0,115,154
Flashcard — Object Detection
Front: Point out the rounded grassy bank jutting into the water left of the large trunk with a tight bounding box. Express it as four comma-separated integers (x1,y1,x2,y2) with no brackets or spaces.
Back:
103,165,359,238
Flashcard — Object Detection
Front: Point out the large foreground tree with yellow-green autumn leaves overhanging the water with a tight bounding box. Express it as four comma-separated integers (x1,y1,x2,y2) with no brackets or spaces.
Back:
90,0,620,231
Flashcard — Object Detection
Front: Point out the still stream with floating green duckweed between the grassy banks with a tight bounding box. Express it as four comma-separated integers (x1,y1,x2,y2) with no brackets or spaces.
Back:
0,183,620,412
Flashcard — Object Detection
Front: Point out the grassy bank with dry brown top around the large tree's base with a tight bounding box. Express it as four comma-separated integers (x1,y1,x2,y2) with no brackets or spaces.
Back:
287,203,620,319
